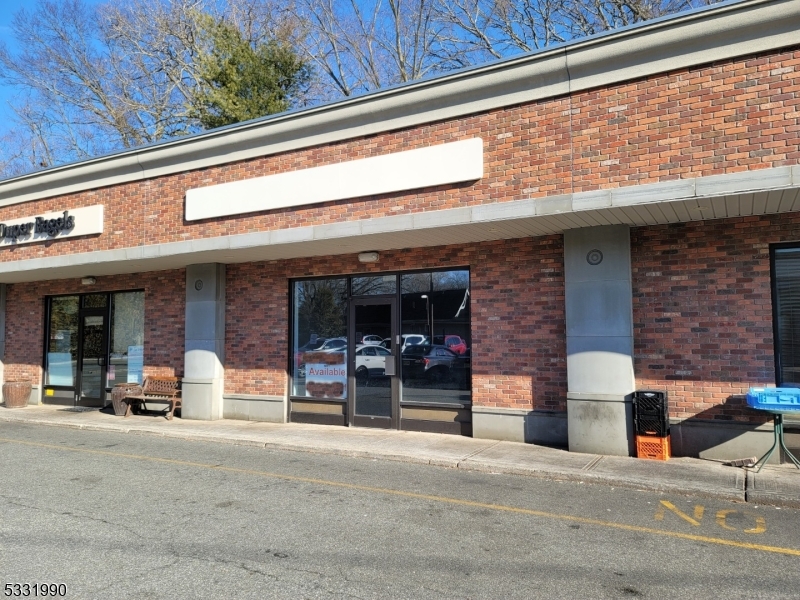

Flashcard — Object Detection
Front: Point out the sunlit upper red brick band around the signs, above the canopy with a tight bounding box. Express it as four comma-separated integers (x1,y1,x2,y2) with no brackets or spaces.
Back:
0,50,800,260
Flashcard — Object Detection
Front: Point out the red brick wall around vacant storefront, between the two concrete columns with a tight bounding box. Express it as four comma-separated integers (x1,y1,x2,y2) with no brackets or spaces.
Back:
225,236,566,410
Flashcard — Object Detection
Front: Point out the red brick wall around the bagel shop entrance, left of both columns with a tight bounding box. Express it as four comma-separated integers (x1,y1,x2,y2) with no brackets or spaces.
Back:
3,269,186,384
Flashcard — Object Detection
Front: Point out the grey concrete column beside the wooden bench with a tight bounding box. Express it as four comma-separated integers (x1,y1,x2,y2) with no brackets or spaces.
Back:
181,263,225,420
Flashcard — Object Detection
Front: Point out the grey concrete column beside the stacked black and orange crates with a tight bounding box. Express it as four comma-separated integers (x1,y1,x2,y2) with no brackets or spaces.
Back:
564,225,635,456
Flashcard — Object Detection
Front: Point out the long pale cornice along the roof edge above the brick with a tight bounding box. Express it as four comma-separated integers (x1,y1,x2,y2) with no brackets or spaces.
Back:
0,0,800,206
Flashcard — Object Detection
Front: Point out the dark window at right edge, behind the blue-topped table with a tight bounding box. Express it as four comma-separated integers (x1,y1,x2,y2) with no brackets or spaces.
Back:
774,248,800,387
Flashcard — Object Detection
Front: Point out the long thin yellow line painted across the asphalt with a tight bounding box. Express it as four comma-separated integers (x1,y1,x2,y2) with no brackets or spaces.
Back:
0,438,800,556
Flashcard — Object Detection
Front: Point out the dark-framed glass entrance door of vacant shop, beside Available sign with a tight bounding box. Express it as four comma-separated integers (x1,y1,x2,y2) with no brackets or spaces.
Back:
348,298,400,429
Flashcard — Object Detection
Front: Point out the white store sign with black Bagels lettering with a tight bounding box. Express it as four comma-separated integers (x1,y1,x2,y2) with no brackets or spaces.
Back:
0,205,103,247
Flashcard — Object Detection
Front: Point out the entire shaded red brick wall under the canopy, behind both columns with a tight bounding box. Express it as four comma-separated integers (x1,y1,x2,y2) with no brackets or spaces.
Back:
9,213,800,421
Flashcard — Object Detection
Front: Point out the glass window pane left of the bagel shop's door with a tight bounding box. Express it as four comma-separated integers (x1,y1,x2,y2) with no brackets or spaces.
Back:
45,296,80,386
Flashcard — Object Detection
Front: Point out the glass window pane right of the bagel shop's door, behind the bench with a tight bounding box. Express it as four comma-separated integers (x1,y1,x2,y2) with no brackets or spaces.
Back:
108,292,144,387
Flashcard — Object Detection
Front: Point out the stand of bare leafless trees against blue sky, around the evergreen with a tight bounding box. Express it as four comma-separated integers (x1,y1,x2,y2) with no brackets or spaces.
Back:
0,0,715,175
